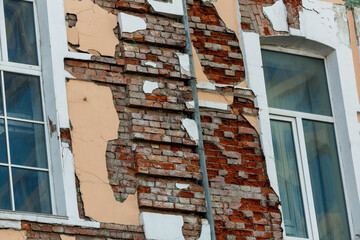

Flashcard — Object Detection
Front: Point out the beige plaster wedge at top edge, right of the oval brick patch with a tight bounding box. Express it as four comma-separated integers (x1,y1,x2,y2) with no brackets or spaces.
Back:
214,0,241,45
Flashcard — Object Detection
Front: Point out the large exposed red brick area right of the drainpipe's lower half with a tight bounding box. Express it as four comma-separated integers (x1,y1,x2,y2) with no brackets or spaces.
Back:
201,94,282,239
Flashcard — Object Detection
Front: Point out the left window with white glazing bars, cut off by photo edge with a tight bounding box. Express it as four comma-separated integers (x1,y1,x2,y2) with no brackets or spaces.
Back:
0,0,54,214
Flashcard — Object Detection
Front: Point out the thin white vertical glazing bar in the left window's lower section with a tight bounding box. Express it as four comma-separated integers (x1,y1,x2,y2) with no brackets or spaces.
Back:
1,71,15,211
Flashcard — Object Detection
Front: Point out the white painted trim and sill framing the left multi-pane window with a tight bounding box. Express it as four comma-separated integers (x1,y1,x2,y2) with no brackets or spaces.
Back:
0,0,100,229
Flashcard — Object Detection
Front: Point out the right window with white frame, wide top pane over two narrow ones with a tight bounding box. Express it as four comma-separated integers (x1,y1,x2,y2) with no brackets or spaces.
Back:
262,50,351,240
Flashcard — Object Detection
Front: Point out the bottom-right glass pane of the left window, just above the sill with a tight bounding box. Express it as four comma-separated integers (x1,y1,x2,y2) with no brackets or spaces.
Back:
12,168,52,214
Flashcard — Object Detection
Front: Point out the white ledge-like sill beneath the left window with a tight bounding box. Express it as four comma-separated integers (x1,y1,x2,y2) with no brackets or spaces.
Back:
0,211,100,229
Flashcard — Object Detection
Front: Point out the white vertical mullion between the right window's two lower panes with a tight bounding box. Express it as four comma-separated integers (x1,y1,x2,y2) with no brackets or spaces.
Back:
295,117,319,240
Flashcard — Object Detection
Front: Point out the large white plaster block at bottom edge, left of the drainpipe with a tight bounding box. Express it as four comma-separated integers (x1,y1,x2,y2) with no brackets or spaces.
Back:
140,212,185,240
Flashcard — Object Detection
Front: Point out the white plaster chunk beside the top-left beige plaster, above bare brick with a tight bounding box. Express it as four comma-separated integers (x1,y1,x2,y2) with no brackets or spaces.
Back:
118,13,146,33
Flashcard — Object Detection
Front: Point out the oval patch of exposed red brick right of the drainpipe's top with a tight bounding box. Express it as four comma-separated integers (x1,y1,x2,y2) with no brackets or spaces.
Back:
188,0,245,85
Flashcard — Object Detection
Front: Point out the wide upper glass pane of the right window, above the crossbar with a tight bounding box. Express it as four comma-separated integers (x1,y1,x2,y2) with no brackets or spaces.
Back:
262,50,332,116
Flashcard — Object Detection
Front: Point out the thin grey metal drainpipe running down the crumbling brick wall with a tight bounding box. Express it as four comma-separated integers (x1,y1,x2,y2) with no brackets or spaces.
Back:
182,0,216,240
